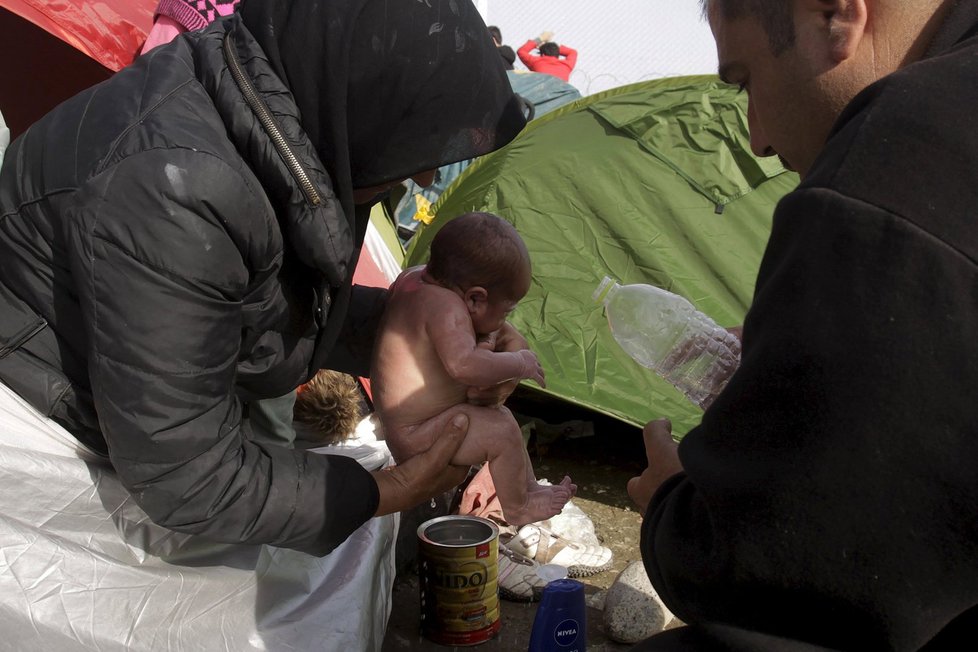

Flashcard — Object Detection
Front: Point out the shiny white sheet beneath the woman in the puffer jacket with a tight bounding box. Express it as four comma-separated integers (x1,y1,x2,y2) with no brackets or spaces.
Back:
0,384,399,652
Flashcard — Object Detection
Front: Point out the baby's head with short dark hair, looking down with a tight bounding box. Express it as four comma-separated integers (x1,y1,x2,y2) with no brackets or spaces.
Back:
427,213,530,335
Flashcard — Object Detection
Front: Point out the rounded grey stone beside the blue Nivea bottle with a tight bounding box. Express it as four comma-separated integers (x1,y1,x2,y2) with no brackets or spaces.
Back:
604,561,674,643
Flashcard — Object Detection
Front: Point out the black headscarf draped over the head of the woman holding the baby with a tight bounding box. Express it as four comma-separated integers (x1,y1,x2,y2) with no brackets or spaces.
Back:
239,0,525,196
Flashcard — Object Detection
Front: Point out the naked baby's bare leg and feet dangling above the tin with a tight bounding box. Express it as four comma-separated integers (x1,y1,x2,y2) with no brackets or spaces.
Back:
453,405,576,527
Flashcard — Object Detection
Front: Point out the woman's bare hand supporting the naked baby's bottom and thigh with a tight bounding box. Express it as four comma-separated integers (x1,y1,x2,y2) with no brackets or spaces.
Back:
371,414,469,516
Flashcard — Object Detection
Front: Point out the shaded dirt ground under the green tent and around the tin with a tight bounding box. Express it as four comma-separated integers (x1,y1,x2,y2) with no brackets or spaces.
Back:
383,392,645,652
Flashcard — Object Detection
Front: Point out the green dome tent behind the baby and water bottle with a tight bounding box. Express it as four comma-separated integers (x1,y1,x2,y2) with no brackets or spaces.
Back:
406,75,798,435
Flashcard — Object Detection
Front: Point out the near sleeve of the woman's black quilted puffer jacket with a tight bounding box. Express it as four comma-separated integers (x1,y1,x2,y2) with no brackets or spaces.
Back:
69,148,378,554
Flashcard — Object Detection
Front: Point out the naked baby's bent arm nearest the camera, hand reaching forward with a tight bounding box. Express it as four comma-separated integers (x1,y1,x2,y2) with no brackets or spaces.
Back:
428,307,546,387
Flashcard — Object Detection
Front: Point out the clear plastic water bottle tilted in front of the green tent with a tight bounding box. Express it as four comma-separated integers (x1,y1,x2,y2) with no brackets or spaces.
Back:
593,276,740,410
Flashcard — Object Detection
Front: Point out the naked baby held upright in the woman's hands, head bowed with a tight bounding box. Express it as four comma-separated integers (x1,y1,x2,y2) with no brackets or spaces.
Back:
370,213,577,527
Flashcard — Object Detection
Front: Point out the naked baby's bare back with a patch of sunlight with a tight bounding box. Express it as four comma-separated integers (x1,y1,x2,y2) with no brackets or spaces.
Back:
370,268,468,438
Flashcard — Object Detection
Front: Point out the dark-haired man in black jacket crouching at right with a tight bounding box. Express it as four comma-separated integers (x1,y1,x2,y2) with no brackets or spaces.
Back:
629,0,978,652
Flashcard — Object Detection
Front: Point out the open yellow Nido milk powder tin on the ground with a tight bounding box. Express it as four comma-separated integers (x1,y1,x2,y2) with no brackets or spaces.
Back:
418,516,500,646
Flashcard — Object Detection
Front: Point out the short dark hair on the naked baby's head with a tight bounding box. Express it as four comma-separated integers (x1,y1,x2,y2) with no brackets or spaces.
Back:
428,213,530,298
